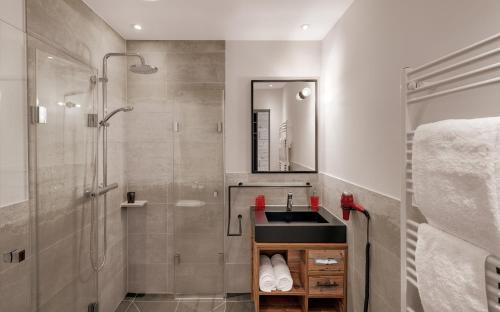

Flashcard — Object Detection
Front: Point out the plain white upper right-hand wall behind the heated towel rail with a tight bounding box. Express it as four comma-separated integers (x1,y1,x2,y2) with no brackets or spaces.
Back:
319,0,500,198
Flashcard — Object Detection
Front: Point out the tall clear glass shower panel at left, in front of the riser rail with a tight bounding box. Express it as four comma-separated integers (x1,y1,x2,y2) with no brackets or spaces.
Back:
34,50,98,312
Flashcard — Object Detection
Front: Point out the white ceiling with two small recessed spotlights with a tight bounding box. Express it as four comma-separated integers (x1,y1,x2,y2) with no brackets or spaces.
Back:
84,0,354,40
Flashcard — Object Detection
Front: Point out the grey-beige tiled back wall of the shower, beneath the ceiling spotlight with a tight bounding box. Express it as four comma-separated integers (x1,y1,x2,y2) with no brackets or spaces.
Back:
126,41,225,294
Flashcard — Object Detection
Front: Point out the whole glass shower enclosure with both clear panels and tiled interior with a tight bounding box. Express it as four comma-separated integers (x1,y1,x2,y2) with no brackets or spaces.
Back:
30,41,225,312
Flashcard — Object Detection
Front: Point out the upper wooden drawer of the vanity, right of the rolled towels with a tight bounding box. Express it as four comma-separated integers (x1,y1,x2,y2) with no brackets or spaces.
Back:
308,250,345,274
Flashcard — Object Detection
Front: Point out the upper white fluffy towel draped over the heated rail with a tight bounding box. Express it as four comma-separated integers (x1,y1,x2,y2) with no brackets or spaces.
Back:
412,117,500,256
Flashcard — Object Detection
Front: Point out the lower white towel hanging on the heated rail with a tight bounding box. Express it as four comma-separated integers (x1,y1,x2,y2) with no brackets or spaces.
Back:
415,224,489,312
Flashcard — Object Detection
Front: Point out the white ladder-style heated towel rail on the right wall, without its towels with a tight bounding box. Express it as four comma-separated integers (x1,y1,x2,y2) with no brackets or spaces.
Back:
401,34,500,312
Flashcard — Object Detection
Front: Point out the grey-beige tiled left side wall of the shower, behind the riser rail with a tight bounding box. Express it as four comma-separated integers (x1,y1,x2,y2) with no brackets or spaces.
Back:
26,0,126,312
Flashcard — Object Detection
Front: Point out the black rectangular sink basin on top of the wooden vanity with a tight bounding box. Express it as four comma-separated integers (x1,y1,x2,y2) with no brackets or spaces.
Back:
252,206,346,244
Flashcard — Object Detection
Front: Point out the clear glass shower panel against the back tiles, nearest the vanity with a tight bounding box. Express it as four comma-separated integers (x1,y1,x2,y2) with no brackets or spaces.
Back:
172,83,224,297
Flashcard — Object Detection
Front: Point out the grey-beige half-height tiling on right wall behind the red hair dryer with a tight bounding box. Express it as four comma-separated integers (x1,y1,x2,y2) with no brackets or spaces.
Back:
319,173,401,312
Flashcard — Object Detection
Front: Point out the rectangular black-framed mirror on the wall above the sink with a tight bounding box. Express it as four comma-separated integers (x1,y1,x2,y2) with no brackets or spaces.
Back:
252,80,318,173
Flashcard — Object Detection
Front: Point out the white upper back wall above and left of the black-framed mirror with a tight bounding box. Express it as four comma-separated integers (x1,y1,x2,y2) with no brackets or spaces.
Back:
225,41,321,172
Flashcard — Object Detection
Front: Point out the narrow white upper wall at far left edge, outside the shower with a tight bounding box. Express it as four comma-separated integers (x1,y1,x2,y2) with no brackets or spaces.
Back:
0,0,28,207
